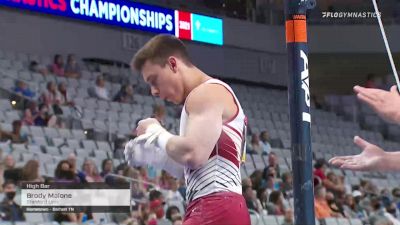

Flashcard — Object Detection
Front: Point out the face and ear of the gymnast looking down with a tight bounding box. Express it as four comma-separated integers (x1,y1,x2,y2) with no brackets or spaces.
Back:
142,56,184,104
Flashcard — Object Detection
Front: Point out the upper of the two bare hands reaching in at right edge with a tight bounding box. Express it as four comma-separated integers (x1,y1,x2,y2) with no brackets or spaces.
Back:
354,86,400,124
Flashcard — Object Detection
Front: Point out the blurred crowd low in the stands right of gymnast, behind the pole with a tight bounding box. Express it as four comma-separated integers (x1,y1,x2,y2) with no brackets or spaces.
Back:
242,148,400,225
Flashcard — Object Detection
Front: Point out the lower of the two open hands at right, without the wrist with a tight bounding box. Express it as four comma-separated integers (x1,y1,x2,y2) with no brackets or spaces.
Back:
329,136,387,171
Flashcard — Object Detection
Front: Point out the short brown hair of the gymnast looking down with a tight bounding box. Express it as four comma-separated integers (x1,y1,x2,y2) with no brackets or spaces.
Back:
131,34,192,71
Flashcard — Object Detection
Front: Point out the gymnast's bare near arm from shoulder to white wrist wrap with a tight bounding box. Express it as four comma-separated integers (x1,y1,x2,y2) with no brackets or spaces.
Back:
167,84,237,169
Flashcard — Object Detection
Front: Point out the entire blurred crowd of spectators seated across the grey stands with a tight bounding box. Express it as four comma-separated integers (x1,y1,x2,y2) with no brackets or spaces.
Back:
0,54,400,225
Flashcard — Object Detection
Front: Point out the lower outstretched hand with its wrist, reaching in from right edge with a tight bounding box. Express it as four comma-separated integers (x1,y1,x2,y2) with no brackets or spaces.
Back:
329,136,400,171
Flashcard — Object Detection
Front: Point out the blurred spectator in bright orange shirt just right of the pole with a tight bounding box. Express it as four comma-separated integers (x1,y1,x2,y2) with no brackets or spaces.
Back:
314,185,339,220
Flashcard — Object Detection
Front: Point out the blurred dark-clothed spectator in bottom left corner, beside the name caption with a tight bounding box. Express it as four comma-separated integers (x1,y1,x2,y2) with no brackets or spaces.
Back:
0,181,25,222
